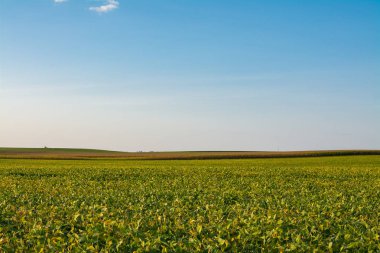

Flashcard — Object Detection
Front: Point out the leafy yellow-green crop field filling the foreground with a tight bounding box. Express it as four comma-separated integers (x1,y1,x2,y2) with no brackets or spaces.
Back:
0,155,380,252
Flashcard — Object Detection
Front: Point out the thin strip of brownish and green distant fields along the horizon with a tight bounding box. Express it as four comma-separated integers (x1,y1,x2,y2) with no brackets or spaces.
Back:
0,148,380,160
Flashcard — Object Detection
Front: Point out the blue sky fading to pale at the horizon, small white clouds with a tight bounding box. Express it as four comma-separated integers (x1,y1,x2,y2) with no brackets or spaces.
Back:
0,0,380,151
